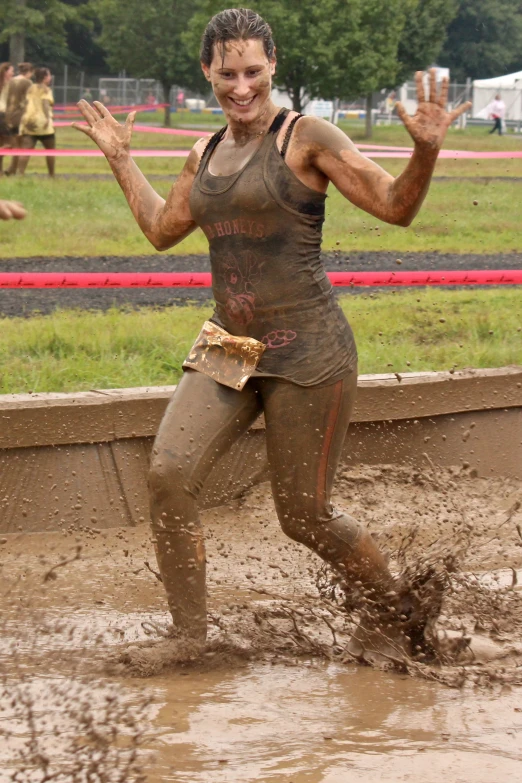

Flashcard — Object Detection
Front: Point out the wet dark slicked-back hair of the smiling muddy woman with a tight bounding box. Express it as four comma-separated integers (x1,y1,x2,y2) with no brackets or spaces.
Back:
199,8,275,67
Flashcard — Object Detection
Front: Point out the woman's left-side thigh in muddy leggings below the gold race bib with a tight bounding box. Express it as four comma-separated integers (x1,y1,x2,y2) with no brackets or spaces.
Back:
152,370,260,494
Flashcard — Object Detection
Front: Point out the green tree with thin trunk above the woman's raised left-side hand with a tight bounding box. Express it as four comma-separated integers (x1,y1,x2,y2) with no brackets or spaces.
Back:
94,0,206,126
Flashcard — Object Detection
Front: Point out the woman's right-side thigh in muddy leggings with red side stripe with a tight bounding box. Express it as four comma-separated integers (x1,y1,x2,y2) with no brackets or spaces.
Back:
260,372,357,522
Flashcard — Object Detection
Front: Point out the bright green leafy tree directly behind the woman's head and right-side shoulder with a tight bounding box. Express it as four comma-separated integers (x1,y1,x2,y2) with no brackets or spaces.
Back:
191,0,412,118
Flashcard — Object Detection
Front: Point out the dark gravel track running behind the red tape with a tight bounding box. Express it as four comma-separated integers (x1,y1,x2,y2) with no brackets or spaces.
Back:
0,252,522,316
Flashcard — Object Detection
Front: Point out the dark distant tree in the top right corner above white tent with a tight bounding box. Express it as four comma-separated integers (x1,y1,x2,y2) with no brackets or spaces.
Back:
442,0,522,82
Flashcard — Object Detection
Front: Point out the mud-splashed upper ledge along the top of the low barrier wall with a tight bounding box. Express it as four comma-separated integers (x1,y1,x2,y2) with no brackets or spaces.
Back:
0,367,522,449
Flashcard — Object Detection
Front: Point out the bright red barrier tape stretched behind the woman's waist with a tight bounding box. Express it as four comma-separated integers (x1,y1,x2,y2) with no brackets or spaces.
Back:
0,269,522,288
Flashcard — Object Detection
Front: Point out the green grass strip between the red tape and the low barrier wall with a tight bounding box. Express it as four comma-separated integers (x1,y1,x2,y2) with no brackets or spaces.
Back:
0,288,522,394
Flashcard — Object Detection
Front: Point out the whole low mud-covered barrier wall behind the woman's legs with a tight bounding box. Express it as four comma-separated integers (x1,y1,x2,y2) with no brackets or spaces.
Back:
0,367,522,532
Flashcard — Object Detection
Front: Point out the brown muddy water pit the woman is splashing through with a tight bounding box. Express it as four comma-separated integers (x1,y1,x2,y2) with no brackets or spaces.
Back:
0,463,522,783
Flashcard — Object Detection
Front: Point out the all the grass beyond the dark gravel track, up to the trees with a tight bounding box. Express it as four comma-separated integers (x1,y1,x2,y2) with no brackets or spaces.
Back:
0,113,522,258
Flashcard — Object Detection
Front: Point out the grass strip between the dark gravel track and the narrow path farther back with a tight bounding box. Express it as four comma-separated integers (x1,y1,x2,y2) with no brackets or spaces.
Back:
0,173,521,258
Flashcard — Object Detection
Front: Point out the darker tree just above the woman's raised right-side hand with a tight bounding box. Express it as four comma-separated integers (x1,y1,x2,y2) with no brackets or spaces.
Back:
394,0,458,87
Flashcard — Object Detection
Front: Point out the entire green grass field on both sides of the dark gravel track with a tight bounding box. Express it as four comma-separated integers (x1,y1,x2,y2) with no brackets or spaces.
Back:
0,114,522,393
